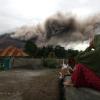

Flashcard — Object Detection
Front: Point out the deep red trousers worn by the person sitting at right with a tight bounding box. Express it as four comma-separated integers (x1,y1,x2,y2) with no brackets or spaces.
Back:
71,64,100,90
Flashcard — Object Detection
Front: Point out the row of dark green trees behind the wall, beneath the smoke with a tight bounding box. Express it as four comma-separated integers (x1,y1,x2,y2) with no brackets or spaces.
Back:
24,40,79,59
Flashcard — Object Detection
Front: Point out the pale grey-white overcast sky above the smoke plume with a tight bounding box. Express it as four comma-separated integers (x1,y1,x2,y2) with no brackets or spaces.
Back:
0,0,100,33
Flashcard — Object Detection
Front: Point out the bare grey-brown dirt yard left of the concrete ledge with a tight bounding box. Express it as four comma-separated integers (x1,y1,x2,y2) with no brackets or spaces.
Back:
0,69,59,100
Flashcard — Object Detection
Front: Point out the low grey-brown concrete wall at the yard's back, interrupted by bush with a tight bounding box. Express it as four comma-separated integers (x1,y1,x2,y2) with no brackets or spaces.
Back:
13,58,66,69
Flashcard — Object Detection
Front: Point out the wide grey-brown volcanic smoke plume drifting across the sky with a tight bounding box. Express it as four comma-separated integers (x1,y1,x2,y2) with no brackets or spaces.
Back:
12,13,100,46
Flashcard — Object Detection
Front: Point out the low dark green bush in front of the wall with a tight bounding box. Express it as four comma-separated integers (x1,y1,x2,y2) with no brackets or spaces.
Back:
42,58,58,68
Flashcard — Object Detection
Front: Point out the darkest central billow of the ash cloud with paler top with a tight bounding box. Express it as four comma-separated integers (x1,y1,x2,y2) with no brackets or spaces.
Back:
45,14,77,39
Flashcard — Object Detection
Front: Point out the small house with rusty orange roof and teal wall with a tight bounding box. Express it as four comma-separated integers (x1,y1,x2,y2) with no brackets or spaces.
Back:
0,46,28,70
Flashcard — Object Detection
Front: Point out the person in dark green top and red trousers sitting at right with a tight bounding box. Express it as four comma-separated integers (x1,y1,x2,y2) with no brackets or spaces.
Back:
64,35,100,90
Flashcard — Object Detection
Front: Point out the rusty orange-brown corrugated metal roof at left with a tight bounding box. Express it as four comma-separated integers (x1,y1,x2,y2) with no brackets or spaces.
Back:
0,46,28,57
